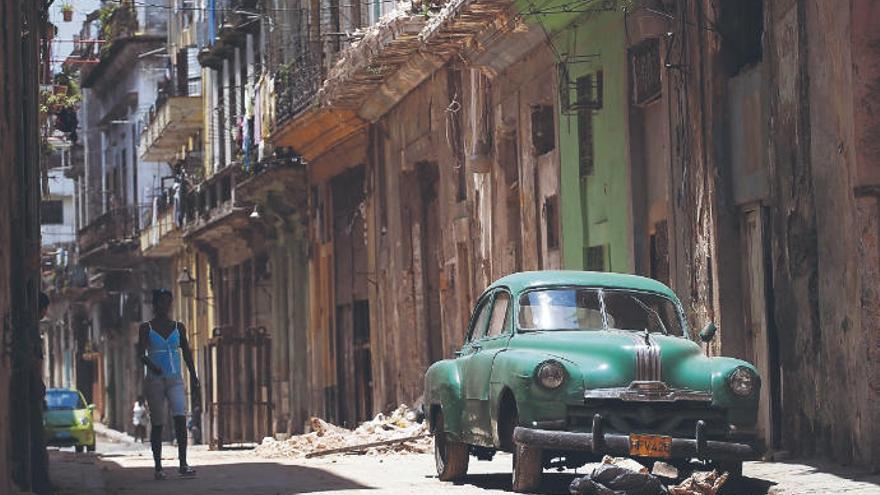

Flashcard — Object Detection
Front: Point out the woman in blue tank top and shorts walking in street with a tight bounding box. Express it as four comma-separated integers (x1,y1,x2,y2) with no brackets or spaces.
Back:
138,289,201,480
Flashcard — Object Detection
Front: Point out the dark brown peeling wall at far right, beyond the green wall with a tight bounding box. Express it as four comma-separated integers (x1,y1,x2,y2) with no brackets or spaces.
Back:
670,0,880,469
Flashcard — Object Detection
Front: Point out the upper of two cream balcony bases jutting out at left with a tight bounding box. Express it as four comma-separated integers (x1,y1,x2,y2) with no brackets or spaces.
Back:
139,96,203,162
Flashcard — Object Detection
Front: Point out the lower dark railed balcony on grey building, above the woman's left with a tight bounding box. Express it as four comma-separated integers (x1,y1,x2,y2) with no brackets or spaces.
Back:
77,207,139,267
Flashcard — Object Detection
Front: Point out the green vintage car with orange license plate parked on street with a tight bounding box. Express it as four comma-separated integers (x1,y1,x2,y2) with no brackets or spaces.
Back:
425,271,760,491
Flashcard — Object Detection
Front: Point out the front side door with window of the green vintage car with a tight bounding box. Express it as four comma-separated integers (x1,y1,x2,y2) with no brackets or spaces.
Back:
462,289,511,446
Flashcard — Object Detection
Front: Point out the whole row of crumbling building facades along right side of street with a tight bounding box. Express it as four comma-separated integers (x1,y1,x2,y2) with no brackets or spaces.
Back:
49,0,880,468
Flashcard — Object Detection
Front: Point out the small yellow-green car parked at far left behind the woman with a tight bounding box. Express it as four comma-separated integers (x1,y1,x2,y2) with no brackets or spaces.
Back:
43,388,95,452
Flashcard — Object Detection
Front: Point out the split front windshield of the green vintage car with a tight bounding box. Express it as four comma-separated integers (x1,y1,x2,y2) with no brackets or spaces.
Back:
519,287,684,337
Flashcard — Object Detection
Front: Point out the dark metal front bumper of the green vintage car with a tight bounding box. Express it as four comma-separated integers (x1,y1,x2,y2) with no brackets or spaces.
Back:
513,414,760,461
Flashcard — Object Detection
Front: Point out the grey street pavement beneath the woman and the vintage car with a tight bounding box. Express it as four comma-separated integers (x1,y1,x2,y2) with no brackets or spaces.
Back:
51,434,880,495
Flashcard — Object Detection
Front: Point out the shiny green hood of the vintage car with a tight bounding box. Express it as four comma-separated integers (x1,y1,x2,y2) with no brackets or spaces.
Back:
510,330,751,398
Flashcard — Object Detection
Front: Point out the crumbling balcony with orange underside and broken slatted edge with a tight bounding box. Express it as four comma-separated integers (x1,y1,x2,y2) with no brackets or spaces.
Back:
271,5,430,162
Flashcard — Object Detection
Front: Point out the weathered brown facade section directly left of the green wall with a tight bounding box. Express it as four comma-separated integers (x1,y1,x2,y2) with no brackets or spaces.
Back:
368,41,561,410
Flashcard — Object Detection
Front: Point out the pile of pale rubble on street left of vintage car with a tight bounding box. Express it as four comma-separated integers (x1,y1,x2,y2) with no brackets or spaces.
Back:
255,405,434,457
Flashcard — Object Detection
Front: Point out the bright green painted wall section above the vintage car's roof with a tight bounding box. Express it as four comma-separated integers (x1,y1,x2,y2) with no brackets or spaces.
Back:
522,5,634,272
